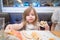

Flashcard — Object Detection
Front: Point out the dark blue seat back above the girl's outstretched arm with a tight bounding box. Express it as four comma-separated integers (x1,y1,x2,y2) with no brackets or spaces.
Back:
9,13,22,24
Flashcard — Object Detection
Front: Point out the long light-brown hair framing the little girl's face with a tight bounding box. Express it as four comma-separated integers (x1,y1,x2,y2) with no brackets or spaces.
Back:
23,7,38,24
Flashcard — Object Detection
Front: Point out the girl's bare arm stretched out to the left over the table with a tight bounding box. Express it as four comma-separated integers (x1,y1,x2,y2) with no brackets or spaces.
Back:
5,23,23,33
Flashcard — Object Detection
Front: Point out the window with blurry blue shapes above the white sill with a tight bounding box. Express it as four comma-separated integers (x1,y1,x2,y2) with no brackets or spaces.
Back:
3,0,60,7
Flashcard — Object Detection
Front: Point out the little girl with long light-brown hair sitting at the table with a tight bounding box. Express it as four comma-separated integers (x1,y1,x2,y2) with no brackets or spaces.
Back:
5,7,49,32
